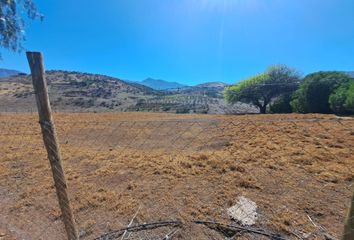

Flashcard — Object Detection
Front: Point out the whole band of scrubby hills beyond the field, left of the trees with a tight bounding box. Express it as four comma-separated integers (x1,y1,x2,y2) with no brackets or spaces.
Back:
0,71,255,114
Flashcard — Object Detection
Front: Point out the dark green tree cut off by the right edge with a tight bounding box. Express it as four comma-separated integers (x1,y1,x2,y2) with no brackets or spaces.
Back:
329,79,354,115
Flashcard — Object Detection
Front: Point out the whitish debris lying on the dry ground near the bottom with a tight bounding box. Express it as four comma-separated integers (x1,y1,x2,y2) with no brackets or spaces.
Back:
227,196,257,226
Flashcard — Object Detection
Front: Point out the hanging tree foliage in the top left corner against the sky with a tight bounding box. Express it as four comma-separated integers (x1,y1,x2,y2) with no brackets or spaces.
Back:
0,0,43,58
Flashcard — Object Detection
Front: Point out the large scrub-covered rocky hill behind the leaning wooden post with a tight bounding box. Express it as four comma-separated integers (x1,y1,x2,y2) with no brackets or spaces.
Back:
0,71,157,111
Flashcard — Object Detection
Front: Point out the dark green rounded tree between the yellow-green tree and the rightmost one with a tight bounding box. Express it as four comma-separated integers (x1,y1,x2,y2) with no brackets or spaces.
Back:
291,72,351,113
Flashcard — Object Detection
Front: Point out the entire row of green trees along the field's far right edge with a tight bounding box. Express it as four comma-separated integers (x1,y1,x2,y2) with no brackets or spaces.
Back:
224,65,354,115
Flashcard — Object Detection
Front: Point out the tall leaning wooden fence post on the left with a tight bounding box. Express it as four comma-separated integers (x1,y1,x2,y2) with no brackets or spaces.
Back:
26,52,79,240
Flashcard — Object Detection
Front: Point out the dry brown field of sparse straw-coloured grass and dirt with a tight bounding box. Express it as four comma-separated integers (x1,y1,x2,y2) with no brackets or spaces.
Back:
0,113,354,239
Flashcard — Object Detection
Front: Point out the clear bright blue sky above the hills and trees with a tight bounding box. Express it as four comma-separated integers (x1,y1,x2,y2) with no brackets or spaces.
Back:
0,0,354,84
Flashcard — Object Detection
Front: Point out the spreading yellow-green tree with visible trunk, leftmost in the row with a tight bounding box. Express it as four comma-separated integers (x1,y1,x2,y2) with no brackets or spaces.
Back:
224,65,300,113
